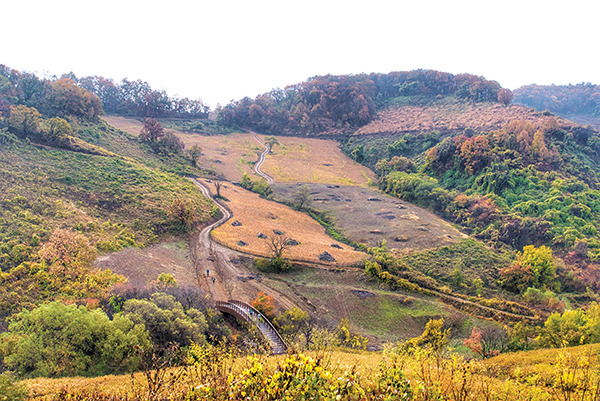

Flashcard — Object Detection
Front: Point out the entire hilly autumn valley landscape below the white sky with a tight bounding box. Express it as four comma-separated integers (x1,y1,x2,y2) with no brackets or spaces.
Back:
0,68,600,401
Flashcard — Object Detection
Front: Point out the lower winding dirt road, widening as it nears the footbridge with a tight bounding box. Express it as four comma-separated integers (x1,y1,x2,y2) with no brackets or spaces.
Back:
191,179,295,309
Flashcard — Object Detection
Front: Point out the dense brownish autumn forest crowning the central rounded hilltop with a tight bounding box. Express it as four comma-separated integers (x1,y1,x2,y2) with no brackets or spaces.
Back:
219,70,512,135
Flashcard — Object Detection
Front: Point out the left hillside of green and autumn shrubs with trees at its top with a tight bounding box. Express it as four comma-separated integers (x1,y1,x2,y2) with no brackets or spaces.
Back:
0,67,215,318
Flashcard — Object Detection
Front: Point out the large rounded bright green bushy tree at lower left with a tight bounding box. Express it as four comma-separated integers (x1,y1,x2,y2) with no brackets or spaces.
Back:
0,302,150,377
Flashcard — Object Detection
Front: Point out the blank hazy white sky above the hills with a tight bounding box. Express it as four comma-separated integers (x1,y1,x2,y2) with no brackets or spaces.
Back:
0,0,600,106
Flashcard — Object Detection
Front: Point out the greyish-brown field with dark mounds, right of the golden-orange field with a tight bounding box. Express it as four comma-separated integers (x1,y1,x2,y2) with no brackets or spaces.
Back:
273,184,466,250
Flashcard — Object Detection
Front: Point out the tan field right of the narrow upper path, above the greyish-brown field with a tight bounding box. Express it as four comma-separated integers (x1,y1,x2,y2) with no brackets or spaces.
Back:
260,135,375,185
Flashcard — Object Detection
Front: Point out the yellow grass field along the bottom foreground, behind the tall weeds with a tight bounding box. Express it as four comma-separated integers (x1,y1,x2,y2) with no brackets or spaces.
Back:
22,346,597,401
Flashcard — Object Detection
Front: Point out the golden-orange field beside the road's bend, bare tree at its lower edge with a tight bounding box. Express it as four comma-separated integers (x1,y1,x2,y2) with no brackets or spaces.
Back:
212,184,366,265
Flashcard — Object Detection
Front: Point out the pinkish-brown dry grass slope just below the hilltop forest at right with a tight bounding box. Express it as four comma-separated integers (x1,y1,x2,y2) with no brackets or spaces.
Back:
355,102,571,135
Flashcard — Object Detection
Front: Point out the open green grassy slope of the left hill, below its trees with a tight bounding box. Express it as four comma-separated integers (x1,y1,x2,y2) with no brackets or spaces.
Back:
0,123,214,315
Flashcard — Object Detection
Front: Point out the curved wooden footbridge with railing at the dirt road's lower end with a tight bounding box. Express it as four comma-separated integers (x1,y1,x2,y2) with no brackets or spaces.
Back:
216,300,287,354
